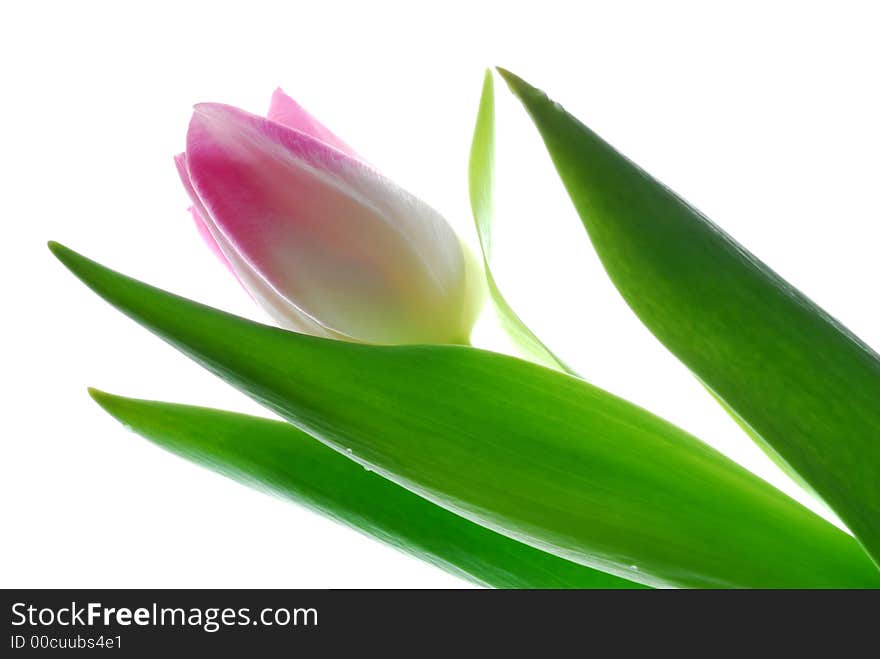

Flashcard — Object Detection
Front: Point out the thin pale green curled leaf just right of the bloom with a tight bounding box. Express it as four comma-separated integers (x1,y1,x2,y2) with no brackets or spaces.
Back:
468,71,573,373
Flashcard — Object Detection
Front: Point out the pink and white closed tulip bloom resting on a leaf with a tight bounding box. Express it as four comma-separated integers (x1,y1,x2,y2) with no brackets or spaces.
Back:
175,89,483,344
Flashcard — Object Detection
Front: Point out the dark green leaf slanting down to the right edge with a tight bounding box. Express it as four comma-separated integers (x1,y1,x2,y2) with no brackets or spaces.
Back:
499,69,880,564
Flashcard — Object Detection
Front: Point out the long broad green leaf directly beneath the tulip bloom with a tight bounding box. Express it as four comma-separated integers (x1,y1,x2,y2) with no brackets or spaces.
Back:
51,244,880,587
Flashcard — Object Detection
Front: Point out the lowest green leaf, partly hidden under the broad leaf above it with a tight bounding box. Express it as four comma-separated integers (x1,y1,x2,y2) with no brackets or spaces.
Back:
90,389,640,588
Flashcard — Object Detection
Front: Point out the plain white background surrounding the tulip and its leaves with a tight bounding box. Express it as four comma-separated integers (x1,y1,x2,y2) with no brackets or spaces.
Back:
0,0,880,587
